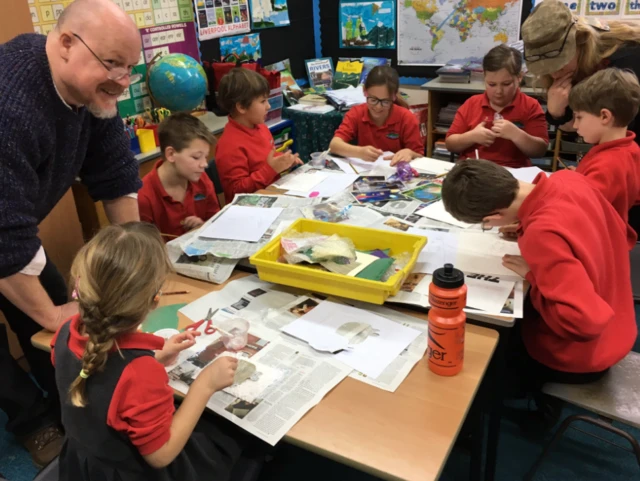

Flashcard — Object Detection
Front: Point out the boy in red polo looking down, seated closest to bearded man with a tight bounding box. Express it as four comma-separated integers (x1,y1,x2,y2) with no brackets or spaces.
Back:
138,113,220,241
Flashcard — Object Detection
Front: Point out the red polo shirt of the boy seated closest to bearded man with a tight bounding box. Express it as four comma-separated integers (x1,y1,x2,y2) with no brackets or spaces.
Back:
138,160,220,241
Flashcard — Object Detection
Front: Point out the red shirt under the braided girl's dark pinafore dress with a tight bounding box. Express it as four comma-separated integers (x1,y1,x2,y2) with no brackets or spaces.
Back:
51,314,175,456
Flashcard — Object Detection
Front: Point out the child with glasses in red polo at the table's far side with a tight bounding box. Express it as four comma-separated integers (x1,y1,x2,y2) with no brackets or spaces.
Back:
329,66,424,165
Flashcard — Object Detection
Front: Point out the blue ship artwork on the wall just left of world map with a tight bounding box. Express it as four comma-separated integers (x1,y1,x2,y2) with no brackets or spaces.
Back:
340,0,396,48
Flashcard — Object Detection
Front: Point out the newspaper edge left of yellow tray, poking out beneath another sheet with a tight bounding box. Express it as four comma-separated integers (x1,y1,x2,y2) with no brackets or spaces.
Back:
167,231,238,284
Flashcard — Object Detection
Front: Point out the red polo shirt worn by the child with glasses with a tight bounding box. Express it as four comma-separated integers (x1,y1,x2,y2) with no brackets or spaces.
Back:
335,104,424,153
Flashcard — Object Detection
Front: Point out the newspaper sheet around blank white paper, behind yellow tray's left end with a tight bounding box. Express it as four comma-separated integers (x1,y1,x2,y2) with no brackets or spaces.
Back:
174,194,321,259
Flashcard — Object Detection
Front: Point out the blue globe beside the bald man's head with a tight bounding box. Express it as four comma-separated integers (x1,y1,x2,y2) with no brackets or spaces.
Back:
147,53,207,111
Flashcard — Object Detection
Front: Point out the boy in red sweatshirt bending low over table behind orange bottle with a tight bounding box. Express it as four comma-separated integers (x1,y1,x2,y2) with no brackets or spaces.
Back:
442,159,637,406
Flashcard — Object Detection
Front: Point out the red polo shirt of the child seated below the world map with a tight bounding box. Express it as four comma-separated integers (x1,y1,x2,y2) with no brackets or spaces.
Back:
447,90,549,168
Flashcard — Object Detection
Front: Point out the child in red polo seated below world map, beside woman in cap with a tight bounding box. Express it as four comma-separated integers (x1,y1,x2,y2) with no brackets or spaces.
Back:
446,45,549,167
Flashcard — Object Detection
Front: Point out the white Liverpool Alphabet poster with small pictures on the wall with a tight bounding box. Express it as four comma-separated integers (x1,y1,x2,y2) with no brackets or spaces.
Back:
196,0,251,40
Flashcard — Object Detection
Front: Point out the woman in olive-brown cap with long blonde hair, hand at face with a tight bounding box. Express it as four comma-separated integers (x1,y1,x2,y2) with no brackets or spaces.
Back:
522,0,640,142
